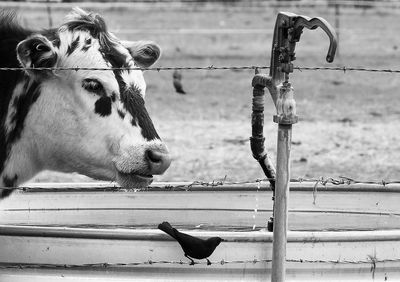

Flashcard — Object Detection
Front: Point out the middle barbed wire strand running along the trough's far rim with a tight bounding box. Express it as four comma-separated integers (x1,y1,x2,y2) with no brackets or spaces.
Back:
0,176,400,193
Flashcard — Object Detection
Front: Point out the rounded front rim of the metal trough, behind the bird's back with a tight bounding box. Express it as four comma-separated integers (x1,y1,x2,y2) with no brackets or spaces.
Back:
0,225,400,243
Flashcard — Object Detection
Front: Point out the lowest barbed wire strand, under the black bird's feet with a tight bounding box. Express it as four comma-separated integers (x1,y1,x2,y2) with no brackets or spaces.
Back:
0,256,400,269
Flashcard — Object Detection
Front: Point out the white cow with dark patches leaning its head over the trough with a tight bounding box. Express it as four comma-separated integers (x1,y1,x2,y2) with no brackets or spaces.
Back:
0,9,171,198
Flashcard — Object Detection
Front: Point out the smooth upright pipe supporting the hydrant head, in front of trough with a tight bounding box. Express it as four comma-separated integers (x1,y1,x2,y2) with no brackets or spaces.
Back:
271,124,292,282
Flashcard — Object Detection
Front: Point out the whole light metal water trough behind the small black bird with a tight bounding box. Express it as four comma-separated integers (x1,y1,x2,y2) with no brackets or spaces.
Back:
0,183,400,282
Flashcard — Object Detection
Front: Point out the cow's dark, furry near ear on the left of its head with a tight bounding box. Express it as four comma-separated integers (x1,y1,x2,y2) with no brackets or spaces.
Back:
17,34,57,74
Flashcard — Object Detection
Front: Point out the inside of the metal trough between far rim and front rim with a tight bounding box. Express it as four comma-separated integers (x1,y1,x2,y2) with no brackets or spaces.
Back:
0,184,400,231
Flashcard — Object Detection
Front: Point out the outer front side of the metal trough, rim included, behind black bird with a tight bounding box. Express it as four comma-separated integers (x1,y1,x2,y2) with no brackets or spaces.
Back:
0,226,400,281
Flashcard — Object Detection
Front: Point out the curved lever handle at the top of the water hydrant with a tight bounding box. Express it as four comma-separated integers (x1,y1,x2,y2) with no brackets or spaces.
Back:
293,16,337,63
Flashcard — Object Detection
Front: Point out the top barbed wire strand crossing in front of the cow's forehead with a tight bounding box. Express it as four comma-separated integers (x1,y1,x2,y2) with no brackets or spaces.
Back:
0,65,400,74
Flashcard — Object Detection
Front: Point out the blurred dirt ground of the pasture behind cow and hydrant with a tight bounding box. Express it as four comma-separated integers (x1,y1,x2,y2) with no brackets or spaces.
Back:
10,3,400,184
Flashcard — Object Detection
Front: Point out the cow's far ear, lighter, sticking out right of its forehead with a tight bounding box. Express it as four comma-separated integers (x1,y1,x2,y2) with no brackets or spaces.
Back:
121,41,161,68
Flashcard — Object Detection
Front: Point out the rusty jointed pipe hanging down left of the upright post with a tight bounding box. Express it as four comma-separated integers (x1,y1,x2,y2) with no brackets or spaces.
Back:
250,73,276,191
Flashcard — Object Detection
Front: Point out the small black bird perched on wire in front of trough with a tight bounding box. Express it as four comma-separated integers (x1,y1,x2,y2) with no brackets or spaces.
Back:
158,221,223,265
